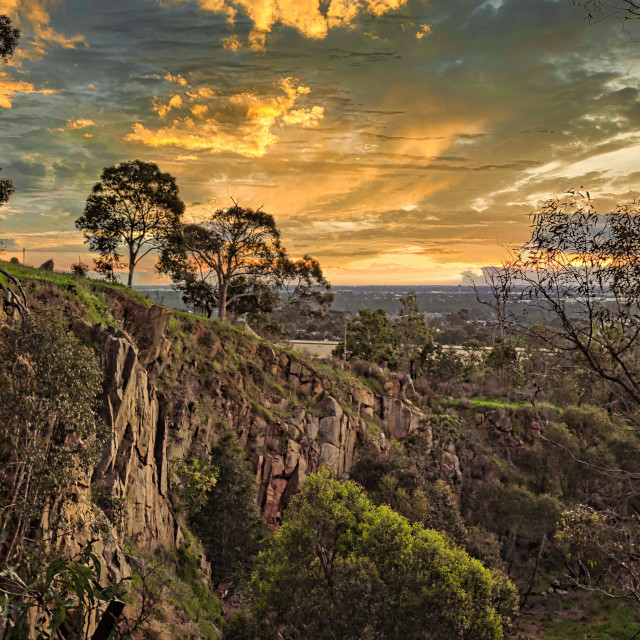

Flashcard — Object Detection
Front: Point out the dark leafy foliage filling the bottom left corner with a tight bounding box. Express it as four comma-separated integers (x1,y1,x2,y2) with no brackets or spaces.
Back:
0,532,123,640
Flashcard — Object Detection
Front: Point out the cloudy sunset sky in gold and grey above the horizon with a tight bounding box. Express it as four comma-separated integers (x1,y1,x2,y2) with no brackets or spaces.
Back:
0,0,640,285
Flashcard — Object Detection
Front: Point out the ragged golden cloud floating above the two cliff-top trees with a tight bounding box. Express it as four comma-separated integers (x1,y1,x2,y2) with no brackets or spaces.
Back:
125,78,324,158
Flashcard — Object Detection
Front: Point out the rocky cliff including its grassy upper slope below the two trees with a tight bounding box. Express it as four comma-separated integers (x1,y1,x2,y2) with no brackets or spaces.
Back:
31,287,423,579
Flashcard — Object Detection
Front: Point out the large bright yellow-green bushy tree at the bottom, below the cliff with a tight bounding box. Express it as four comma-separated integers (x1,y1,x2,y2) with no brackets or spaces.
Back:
235,470,515,640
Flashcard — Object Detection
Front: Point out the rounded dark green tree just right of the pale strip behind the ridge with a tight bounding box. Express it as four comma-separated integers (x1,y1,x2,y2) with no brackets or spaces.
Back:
333,309,400,369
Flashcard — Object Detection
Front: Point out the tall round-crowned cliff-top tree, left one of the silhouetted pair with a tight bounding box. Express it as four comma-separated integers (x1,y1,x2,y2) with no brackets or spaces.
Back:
76,160,184,287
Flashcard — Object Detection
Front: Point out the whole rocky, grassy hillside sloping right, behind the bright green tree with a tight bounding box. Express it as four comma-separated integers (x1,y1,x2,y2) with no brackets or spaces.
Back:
0,263,639,638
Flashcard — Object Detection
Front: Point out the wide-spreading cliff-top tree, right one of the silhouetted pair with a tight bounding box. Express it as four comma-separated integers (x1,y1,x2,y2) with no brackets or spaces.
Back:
159,203,333,320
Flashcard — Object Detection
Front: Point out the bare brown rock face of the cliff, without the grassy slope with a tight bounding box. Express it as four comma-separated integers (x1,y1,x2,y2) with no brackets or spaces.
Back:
66,306,430,557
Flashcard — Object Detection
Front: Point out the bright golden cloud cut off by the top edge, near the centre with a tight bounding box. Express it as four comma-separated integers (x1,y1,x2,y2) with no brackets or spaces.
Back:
160,0,407,43
